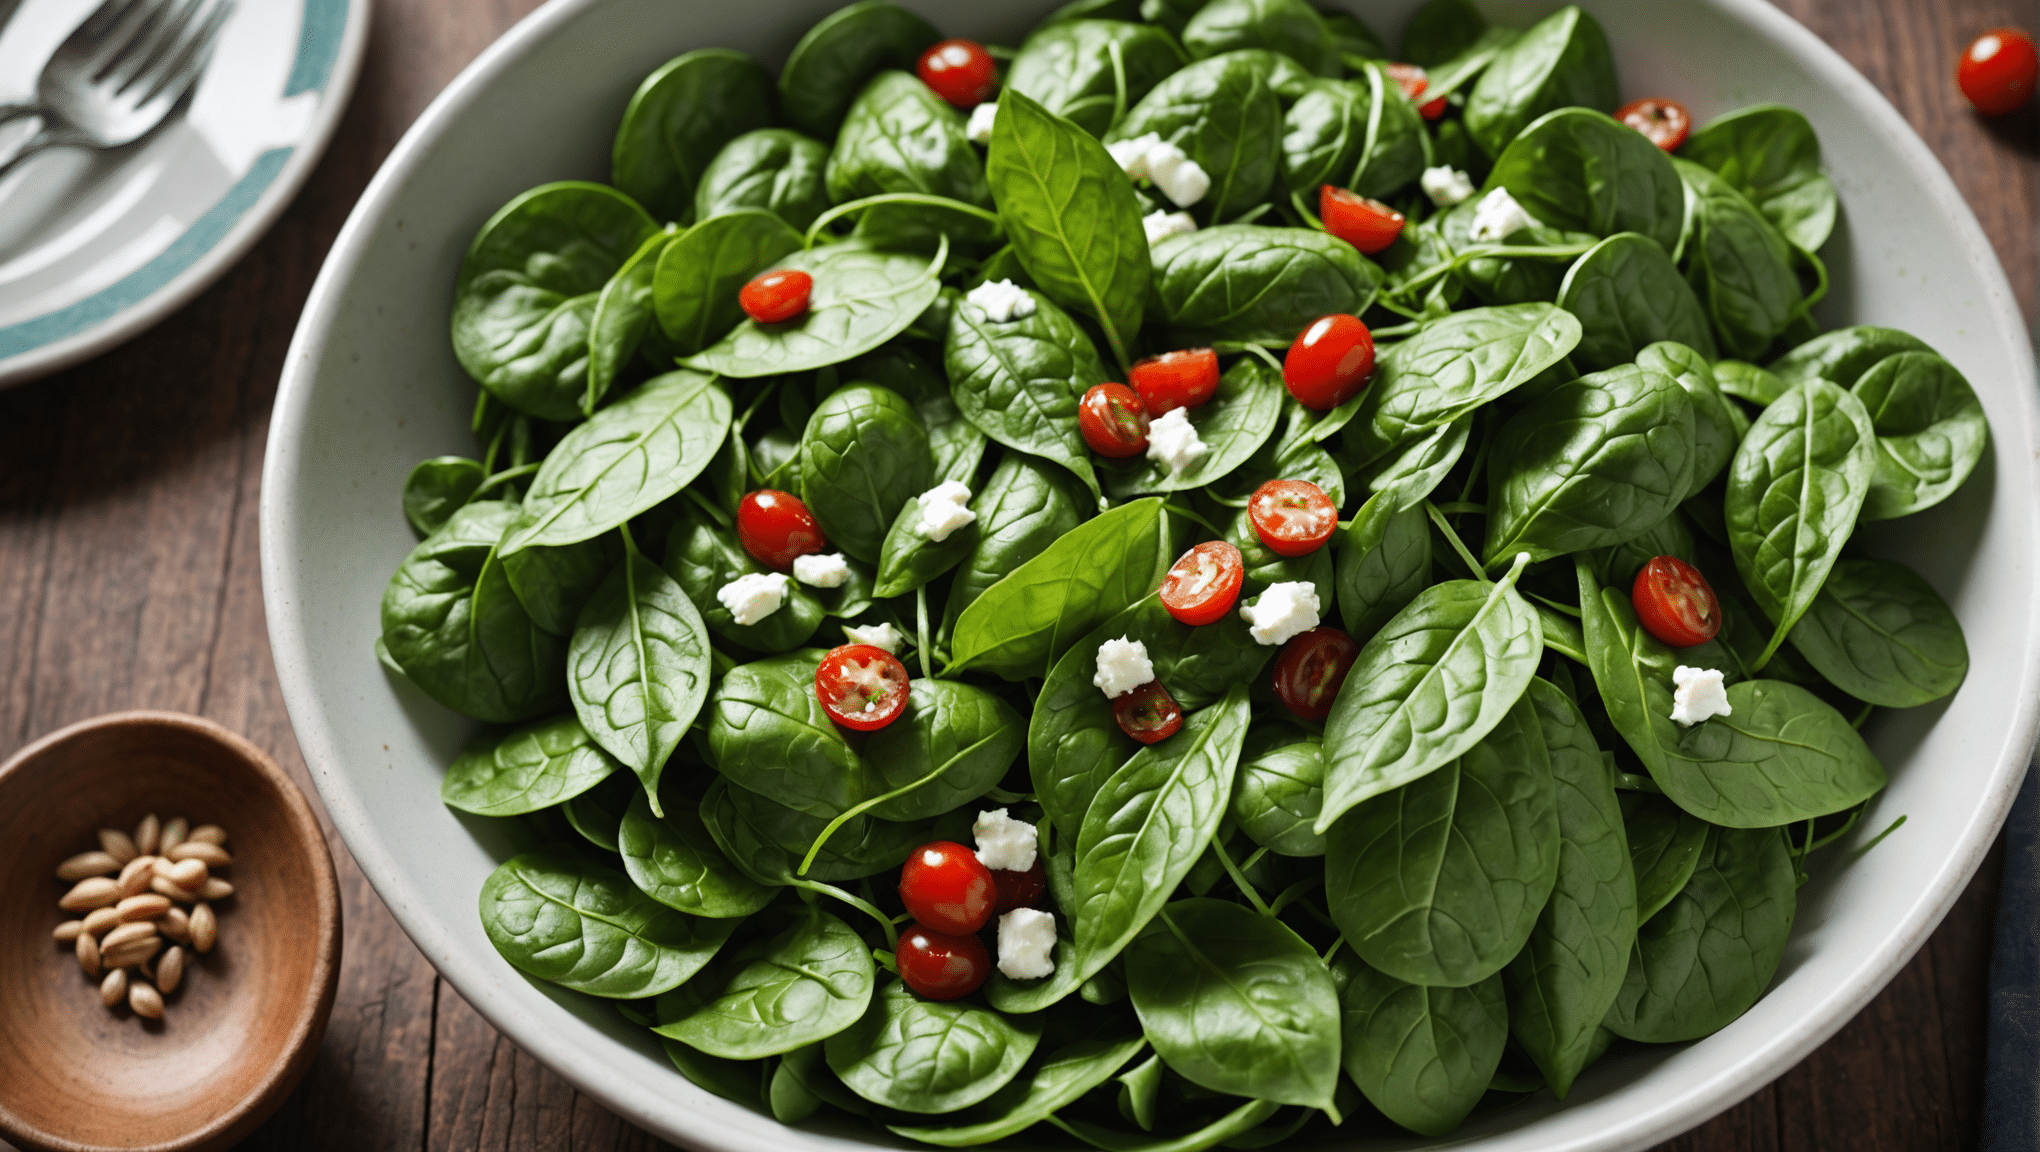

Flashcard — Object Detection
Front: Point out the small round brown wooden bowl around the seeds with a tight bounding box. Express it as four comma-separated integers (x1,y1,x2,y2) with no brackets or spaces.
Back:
0,712,341,1152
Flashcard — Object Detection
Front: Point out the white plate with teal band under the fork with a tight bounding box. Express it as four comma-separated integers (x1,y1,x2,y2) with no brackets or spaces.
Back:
0,0,369,387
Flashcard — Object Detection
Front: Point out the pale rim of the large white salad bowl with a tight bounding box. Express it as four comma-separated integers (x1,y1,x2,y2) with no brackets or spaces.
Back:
259,0,2040,1152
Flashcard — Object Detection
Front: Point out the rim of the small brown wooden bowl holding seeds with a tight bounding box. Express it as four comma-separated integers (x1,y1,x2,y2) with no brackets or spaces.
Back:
0,710,343,1152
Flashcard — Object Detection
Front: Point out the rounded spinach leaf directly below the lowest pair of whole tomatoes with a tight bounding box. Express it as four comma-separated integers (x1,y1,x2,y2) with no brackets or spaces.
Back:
824,981,1042,1113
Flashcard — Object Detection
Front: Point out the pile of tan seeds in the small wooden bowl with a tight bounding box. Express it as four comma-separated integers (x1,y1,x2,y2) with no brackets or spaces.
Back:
55,811,235,1019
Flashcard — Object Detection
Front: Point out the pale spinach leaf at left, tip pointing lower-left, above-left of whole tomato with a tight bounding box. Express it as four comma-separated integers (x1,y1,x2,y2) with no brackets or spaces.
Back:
502,369,730,557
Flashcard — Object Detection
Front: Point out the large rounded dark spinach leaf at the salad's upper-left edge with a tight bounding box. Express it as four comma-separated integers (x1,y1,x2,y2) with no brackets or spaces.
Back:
453,181,659,420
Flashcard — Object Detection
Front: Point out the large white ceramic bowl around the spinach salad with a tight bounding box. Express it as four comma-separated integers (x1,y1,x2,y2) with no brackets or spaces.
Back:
261,0,2040,1152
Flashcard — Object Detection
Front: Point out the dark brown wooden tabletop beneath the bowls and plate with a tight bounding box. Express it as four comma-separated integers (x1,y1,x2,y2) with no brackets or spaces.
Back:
0,0,2040,1152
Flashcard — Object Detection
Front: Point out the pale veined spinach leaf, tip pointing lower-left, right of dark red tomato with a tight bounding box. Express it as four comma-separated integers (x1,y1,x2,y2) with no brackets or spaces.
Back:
1316,567,1544,827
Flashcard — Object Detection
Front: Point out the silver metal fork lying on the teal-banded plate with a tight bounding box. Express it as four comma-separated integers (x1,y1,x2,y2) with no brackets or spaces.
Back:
0,0,235,177
